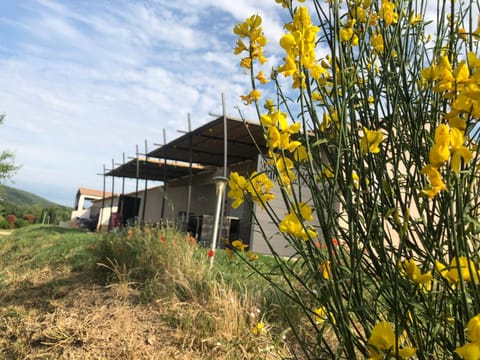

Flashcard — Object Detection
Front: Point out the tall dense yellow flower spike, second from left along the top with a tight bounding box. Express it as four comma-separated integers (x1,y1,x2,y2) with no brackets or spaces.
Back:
278,6,327,89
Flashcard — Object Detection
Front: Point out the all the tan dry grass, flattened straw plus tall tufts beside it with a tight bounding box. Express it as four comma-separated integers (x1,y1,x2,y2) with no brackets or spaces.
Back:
0,226,294,360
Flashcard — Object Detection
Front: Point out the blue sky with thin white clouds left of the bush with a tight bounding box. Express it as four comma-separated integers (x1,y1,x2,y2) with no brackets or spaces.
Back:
0,0,283,206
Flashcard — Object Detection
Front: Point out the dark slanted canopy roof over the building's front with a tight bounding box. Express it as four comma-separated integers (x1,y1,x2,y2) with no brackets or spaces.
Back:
105,116,265,181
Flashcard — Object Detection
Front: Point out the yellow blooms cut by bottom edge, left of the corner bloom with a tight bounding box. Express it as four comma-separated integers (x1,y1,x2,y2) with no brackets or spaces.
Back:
368,320,417,360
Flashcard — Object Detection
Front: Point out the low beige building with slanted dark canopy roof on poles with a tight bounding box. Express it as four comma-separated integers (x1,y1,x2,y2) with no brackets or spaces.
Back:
94,116,316,256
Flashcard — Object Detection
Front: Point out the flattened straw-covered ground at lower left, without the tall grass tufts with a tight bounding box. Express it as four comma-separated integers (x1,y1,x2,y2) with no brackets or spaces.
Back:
0,270,206,360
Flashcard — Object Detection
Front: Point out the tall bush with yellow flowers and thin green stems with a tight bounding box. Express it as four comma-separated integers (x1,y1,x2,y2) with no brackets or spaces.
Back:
228,0,480,359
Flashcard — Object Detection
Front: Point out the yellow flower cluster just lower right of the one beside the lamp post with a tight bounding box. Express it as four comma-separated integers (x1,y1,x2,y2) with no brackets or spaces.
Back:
278,202,317,241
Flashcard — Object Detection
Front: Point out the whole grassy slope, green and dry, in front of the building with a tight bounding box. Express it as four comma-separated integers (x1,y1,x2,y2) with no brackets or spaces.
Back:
0,226,298,359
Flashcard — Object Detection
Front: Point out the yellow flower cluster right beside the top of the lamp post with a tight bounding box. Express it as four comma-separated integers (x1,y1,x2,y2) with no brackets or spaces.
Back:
227,171,274,209
